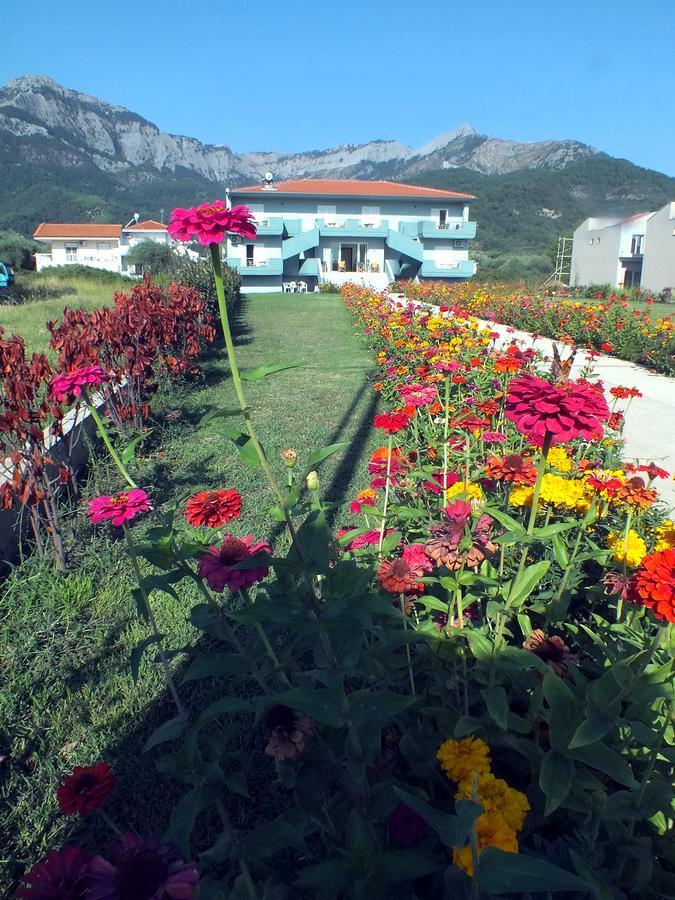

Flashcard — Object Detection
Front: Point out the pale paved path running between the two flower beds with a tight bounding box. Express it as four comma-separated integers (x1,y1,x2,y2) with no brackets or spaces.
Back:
390,294,675,510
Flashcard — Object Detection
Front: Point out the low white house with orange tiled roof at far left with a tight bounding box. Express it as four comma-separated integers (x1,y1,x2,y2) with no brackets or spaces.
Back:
33,218,173,274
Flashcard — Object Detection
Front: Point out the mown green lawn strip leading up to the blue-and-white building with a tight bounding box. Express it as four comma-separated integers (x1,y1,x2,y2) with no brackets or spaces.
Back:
0,294,376,896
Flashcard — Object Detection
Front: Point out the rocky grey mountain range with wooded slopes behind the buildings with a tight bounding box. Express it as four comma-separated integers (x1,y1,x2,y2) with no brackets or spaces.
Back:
0,75,675,278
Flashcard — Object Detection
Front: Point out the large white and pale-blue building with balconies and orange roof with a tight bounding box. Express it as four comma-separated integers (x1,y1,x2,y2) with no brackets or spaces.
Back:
227,175,476,292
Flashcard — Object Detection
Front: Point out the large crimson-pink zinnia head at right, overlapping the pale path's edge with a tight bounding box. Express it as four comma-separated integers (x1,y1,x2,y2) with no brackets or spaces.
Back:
506,375,609,445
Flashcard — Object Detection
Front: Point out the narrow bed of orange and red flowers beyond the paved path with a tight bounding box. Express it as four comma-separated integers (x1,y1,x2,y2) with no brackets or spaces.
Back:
396,281,675,375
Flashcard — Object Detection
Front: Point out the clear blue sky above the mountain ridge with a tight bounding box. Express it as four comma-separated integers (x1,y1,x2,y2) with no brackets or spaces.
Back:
5,0,675,175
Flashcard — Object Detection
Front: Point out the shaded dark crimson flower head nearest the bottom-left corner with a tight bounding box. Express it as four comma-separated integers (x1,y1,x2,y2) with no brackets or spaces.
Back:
17,847,91,900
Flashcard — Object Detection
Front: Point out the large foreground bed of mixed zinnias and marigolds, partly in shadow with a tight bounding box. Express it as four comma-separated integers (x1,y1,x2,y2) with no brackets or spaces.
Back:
11,218,675,900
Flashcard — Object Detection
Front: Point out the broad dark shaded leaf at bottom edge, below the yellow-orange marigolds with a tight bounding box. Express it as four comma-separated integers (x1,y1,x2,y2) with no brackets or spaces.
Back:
480,847,592,897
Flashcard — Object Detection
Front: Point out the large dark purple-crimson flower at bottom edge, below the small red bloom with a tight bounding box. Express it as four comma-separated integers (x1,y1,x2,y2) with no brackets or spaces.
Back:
86,832,199,900
